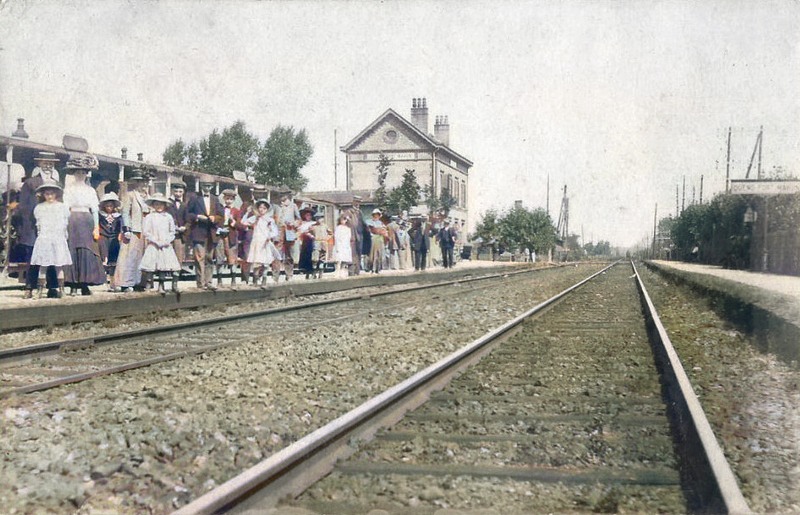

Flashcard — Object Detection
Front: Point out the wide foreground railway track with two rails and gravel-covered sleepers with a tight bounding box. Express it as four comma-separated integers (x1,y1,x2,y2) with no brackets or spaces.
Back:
177,266,749,514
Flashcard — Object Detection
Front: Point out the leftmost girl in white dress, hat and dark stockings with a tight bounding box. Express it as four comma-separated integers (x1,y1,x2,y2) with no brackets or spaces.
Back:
31,181,72,298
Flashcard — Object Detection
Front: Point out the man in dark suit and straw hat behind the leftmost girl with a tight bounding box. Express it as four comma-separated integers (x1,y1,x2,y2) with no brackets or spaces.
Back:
9,152,59,298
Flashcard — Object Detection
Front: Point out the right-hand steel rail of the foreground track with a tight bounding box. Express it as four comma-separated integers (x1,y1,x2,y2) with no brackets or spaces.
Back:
631,261,752,515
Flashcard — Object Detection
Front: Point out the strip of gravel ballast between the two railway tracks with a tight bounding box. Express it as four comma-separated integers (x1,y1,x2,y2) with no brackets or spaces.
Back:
0,266,599,513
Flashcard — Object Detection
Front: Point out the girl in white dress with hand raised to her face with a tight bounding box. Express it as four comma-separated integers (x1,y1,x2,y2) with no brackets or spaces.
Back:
247,199,282,289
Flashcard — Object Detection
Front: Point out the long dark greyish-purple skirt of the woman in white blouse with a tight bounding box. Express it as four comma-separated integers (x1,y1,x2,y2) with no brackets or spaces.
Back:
64,213,106,285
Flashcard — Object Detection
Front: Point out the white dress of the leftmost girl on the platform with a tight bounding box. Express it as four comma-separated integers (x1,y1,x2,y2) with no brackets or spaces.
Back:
31,202,72,266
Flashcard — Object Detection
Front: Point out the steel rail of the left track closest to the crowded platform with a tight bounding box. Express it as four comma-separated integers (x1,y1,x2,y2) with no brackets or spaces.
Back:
0,268,550,365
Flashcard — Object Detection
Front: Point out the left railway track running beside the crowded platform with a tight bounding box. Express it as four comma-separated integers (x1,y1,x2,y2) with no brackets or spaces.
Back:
0,270,544,398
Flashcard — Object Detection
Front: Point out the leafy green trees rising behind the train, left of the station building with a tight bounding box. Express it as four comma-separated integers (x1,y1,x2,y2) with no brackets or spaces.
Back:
162,120,314,191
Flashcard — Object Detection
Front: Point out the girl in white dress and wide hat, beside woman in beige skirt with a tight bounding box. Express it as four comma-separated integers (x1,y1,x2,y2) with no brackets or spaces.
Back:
139,193,181,295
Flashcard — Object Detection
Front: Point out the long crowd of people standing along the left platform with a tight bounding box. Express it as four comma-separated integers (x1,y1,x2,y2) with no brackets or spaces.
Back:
10,152,460,298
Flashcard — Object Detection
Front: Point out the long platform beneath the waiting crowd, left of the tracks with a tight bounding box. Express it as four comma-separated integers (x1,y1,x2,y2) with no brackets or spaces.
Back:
0,261,540,333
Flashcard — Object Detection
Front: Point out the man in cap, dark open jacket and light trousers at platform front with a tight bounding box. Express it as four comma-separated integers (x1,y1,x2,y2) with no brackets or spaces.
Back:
186,176,224,290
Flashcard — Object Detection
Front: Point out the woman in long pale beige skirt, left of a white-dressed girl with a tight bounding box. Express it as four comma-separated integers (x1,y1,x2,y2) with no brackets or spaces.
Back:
114,168,150,292
